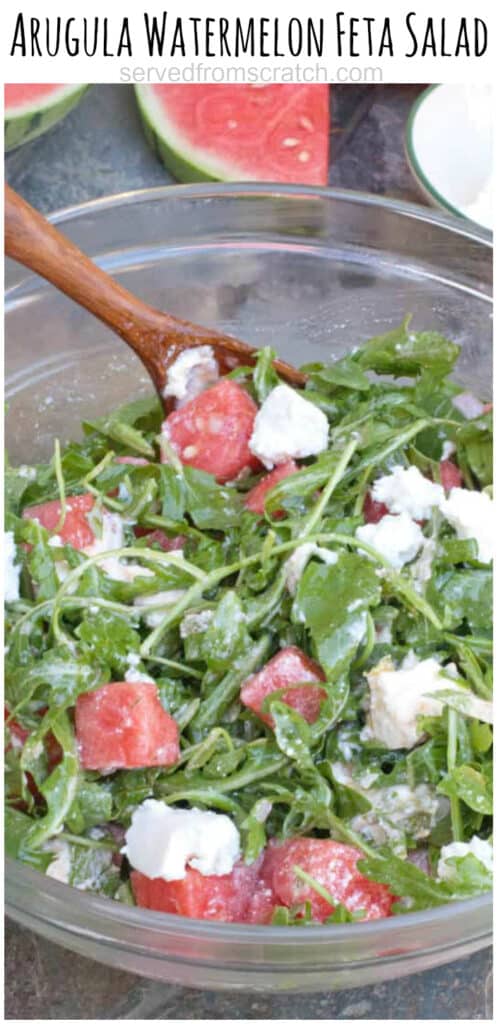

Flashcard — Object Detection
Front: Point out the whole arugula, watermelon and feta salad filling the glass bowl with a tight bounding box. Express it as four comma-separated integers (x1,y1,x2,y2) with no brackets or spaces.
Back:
5,321,495,926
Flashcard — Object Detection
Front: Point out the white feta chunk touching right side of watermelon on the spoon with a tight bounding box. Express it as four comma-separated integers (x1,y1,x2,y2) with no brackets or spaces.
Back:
249,384,329,469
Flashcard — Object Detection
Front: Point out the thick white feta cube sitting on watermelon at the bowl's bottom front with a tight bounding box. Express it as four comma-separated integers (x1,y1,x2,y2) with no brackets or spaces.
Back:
122,800,241,882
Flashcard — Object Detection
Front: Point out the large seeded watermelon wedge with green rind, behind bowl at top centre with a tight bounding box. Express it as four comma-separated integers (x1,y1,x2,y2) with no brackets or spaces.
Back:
135,84,329,185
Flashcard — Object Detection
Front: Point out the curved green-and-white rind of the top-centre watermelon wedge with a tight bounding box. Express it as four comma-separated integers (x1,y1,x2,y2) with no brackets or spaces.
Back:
134,85,253,182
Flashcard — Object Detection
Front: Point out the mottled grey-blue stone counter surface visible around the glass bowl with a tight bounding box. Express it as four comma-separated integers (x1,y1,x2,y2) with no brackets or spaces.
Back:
5,85,493,1020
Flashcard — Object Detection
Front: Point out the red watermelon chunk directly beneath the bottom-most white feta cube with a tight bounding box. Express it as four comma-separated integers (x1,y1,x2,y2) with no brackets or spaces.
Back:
131,862,259,922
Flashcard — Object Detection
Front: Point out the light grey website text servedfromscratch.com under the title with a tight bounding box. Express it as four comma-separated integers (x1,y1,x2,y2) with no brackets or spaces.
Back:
120,60,383,85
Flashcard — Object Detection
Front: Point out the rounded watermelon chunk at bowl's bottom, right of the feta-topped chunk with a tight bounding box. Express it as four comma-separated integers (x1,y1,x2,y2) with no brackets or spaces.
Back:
261,838,395,922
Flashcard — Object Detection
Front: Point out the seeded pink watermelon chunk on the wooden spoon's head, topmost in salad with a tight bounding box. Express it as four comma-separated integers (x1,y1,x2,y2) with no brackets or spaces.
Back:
162,380,259,483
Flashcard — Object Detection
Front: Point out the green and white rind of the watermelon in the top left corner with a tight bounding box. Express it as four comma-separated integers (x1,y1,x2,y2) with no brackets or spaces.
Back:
4,84,89,153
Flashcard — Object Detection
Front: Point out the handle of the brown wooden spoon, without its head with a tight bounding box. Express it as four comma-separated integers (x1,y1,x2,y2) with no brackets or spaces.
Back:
5,185,167,358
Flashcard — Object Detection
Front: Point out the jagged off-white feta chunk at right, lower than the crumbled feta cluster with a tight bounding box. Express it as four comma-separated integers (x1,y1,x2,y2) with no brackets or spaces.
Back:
367,657,462,751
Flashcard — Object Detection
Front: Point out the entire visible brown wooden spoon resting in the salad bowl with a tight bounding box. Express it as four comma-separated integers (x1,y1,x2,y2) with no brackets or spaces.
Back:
5,185,306,412
